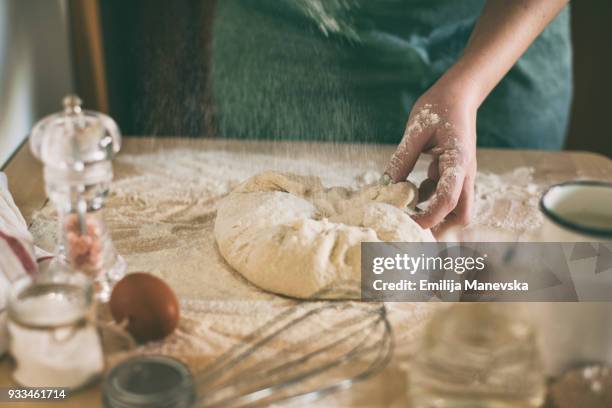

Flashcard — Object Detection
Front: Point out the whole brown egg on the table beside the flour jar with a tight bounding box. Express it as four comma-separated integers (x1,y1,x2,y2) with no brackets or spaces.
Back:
110,272,179,343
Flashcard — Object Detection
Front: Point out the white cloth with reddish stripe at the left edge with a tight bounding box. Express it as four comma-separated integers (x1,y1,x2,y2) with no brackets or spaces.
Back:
0,173,37,354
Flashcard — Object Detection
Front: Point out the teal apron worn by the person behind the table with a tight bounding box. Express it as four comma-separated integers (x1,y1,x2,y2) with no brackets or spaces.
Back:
211,0,571,149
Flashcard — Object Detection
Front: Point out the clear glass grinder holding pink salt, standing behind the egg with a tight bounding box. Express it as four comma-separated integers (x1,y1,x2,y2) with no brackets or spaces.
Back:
30,95,126,301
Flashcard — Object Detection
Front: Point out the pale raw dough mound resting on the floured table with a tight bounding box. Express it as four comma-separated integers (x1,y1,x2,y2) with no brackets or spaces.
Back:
215,172,434,298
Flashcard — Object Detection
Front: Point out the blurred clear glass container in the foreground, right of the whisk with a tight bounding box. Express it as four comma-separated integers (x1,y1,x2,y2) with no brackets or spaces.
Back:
409,303,546,408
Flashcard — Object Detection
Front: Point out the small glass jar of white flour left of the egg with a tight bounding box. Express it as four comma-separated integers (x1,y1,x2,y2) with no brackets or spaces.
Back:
8,271,104,389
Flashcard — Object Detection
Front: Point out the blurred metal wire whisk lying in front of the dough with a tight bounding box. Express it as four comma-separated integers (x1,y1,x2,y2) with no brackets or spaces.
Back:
194,288,393,407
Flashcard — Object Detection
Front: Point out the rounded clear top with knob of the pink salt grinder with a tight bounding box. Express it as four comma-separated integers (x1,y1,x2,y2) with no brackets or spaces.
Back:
30,95,121,171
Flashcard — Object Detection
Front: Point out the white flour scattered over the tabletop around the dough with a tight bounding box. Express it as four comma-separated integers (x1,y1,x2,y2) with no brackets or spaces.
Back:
30,148,539,370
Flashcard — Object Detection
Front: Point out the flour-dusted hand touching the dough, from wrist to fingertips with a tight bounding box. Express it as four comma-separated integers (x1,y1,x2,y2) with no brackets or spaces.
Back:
385,77,478,228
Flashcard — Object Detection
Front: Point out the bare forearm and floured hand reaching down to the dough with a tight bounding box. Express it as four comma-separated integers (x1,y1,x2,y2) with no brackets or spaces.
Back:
385,0,568,228
